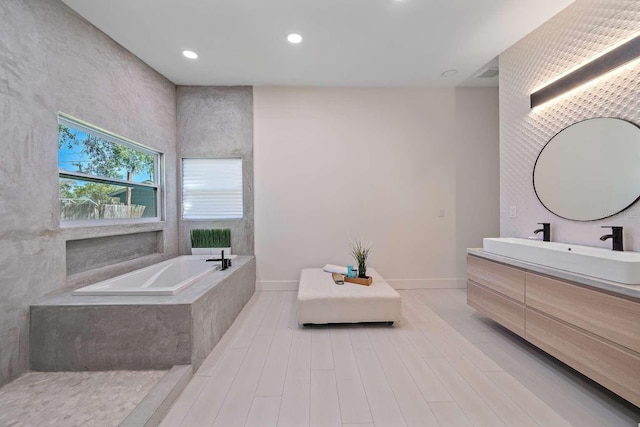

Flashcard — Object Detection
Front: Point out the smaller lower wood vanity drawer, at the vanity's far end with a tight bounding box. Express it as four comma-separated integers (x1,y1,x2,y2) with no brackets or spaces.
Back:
467,280,524,337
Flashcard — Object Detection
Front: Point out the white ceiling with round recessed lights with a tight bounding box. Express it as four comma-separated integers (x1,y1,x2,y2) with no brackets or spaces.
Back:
63,0,573,86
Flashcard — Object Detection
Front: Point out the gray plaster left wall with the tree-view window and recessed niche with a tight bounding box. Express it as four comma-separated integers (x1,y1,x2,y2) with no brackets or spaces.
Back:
0,0,178,385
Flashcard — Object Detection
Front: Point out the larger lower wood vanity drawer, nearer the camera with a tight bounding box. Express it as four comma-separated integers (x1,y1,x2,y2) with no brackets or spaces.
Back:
526,309,640,405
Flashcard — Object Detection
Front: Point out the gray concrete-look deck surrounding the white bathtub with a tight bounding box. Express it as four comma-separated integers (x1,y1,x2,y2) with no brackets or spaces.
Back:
29,256,256,371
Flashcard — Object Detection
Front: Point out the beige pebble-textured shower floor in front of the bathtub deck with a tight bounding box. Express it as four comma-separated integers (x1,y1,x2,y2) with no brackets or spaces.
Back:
0,371,166,427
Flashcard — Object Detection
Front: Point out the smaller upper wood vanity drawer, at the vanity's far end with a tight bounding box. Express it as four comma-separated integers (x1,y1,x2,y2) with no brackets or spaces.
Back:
467,255,525,303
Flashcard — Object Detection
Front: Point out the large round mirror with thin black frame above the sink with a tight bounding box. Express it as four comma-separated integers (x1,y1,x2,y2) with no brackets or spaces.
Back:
533,118,640,221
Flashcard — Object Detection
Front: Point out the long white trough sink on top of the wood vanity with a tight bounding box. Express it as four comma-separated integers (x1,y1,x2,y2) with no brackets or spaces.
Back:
482,237,640,285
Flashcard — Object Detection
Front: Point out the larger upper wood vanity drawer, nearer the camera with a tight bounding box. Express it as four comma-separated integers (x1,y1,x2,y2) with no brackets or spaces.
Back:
526,272,640,353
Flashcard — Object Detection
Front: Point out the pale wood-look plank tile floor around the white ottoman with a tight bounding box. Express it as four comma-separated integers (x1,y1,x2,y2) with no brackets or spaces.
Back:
162,289,640,427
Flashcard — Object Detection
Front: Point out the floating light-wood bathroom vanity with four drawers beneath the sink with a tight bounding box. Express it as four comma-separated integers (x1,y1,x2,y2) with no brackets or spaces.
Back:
467,249,640,406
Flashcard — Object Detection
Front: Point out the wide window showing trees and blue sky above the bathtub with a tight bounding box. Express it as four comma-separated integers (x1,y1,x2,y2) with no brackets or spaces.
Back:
58,115,160,221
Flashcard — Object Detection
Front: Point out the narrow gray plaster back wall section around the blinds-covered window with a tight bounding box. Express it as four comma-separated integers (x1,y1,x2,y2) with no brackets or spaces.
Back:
177,86,254,255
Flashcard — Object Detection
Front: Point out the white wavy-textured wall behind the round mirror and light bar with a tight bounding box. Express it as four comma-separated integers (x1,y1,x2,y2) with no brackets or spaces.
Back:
500,0,640,251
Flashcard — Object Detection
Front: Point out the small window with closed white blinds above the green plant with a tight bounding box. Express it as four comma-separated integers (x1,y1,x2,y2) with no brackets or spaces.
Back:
182,159,243,219
